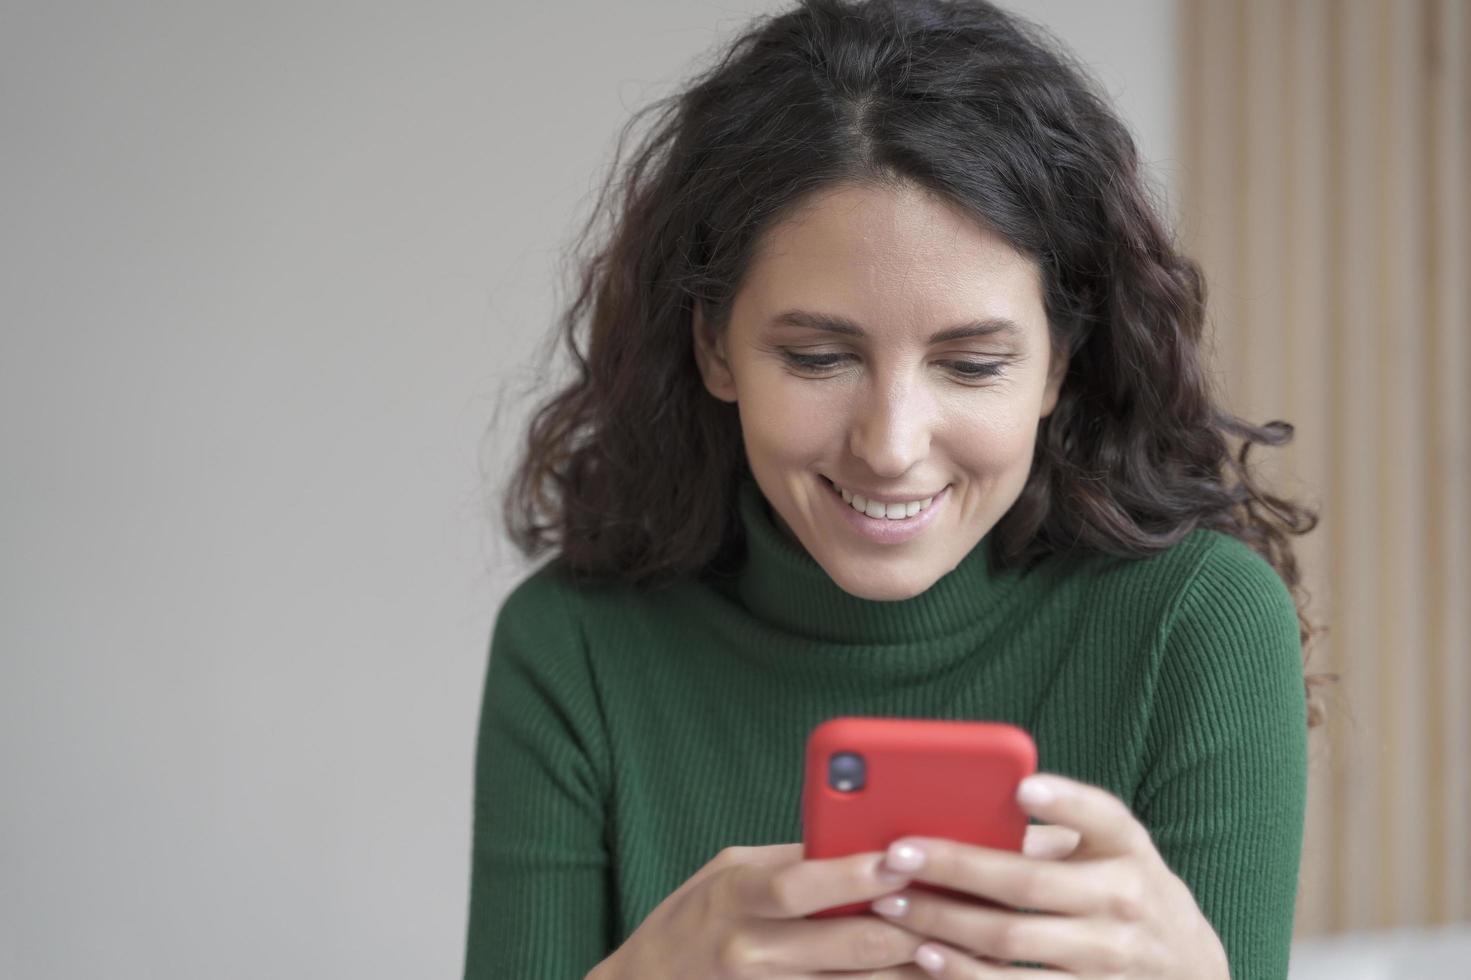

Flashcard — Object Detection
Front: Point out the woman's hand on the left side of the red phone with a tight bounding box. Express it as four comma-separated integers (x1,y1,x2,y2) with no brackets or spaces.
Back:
588,843,930,980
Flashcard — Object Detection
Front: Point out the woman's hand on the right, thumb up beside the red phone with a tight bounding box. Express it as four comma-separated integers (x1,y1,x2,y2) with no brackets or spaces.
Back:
874,773,1230,980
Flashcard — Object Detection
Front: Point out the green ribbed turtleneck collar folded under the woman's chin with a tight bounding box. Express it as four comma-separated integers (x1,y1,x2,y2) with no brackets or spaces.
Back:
734,477,1019,646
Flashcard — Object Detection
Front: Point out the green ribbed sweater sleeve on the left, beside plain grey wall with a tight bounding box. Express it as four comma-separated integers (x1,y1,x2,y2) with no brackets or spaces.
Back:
465,569,612,980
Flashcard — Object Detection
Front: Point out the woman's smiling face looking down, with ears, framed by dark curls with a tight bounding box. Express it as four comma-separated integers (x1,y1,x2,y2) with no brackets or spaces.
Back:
694,179,1066,599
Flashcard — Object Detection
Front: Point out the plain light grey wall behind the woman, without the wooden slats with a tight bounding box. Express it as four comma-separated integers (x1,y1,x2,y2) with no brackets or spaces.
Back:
0,0,1175,980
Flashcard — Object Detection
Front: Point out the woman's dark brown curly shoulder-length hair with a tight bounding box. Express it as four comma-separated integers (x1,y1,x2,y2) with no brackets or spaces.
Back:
491,0,1334,728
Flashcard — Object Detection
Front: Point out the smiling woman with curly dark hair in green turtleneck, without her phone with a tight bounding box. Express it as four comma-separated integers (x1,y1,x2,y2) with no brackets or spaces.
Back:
466,0,1335,980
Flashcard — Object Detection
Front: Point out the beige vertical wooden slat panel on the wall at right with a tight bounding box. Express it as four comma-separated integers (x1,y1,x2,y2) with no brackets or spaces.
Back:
1181,0,1471,934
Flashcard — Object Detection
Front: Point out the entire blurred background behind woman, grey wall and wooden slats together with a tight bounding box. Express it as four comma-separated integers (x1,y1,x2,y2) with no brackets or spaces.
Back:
0,0,1471,980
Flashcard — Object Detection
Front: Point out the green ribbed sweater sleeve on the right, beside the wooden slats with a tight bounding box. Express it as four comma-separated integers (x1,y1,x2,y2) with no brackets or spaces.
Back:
1136,536,1308,980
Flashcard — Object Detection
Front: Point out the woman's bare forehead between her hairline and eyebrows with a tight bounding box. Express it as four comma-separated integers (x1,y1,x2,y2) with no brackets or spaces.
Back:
737,185,1046,335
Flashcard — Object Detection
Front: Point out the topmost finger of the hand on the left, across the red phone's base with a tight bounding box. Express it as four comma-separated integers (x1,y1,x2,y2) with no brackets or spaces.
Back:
727,851,912,918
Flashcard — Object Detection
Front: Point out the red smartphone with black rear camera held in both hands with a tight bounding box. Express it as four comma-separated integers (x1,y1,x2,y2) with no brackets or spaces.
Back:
802,715,1037,918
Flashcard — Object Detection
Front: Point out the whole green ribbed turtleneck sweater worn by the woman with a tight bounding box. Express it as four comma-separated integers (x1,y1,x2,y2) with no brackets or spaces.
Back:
465,478,1308,980
